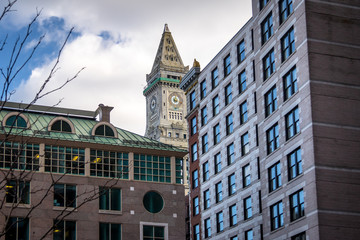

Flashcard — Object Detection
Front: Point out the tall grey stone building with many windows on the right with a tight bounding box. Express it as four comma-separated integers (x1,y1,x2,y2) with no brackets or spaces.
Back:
180,0,360,240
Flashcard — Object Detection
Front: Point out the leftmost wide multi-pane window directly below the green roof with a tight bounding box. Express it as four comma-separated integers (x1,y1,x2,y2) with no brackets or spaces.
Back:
0,141,40,171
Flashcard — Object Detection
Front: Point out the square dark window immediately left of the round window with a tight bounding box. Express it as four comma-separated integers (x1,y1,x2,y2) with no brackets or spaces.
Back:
99,187,121,211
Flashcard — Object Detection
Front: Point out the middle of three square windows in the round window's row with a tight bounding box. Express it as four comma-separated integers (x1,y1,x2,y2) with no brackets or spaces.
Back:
54,184,76,208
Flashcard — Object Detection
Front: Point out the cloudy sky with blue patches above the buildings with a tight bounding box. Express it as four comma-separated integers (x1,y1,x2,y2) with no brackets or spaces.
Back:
0,0,252,135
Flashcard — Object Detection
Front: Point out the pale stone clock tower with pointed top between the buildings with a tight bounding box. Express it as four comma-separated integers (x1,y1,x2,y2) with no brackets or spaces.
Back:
143,24,189,150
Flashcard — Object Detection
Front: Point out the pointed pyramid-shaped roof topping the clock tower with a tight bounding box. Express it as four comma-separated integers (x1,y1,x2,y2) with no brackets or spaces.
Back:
149,24,185,82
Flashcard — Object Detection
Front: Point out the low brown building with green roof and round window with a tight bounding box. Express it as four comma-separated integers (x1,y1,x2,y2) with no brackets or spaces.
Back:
0,102,186,240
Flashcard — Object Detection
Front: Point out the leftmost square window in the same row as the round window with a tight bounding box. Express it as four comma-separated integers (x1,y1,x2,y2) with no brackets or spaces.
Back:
5,180,30,204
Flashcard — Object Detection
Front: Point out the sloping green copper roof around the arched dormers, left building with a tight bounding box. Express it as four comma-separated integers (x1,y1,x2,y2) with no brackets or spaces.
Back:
0,110,186,152
